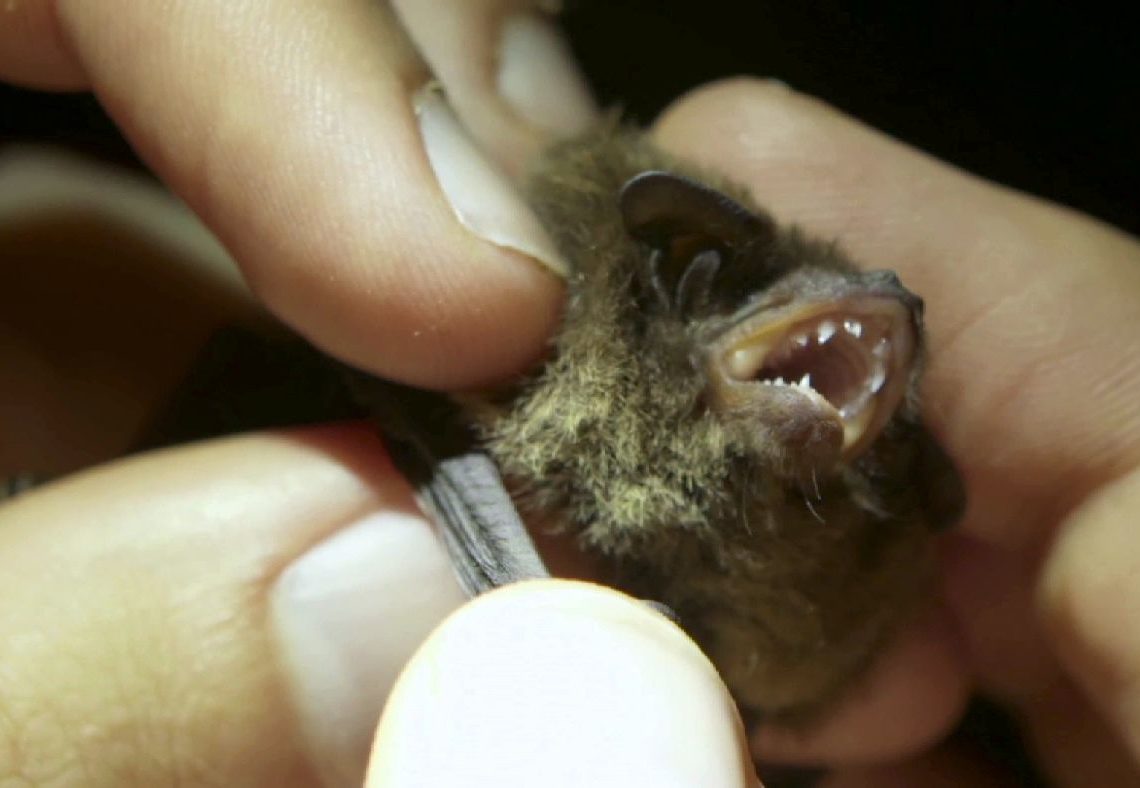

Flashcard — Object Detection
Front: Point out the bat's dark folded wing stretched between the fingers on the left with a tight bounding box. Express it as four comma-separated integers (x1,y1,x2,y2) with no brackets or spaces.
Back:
135,328,548,594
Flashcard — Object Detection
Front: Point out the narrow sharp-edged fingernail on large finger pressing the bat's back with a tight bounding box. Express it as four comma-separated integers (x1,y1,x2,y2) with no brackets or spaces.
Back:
415,82,567,276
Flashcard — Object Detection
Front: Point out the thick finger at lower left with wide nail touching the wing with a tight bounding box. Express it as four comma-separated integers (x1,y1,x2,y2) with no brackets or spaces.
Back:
0,427,462,787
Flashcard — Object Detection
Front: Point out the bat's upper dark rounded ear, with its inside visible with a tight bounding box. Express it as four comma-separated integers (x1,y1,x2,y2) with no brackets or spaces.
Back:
620,170,775,316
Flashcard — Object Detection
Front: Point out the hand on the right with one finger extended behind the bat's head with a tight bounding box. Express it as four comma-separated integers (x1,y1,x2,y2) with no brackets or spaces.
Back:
657,82,1140,787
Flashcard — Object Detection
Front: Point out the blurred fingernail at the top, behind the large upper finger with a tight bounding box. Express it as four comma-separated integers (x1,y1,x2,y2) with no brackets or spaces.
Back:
498,14,599,136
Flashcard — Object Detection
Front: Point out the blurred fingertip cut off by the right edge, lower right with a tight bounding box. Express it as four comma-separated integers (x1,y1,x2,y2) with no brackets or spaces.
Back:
1039,471,1140,785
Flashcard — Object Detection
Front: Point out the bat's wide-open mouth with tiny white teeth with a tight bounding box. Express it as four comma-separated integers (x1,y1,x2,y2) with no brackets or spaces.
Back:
710,293,918,461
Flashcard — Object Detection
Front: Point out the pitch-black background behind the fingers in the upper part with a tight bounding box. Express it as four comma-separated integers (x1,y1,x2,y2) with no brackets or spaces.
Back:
0,0,1140,233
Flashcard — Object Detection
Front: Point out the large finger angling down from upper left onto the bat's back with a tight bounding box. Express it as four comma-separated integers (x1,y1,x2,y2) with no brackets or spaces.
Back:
0,0,588,387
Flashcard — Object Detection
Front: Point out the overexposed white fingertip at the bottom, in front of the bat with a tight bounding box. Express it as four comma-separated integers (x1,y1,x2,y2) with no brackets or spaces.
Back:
367,580,757,788
